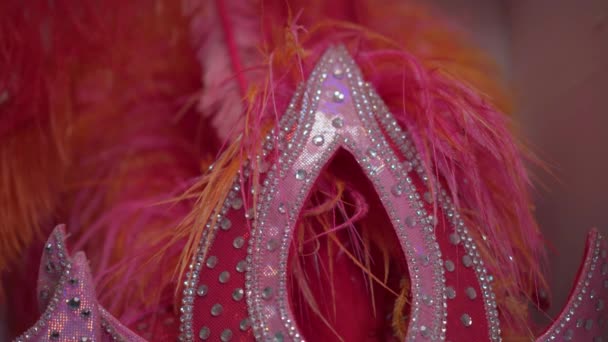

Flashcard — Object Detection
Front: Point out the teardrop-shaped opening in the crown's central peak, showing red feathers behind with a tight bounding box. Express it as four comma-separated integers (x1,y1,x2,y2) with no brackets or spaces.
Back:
287,149,410,341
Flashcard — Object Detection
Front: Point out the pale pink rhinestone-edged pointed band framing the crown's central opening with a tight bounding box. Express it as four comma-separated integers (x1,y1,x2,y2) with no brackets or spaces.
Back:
246,48,447,341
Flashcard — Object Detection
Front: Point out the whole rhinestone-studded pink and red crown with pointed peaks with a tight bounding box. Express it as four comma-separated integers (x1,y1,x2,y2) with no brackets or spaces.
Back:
17,47,608,341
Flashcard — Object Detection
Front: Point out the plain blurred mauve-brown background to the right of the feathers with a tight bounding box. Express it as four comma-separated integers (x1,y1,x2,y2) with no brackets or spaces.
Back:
434,0,608,316
